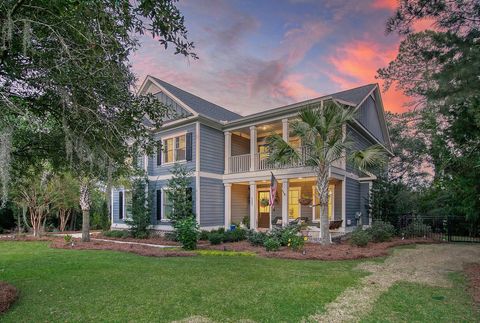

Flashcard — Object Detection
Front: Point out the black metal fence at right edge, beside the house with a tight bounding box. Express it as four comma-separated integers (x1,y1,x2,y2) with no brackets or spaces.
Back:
396,214,480,243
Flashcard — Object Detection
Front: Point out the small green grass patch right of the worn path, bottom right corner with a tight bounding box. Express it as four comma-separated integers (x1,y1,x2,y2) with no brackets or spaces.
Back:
362,273,480,323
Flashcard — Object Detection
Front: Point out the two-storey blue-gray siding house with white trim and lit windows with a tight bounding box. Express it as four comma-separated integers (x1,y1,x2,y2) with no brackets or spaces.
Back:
112,76,391,232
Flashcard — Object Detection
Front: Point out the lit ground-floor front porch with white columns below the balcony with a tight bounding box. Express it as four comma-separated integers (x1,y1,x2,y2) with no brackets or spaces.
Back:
225,177,346,232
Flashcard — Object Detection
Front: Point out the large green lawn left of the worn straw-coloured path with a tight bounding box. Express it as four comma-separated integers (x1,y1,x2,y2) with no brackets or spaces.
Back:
0,242,365,322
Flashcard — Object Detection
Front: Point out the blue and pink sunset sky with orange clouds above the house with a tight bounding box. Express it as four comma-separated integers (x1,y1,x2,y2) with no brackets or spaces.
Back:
131,0,428,115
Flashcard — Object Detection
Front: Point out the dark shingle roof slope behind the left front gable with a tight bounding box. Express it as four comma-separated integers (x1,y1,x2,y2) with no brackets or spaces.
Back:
152,77,242,121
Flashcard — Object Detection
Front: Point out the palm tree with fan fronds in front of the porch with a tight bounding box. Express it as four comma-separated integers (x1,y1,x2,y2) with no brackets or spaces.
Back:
267,101,386,244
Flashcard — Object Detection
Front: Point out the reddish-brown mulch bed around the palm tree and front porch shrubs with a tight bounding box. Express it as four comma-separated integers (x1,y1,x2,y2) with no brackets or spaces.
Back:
199,239,436,260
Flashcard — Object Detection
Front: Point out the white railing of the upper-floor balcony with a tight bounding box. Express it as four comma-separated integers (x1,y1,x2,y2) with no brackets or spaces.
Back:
229,147,345,174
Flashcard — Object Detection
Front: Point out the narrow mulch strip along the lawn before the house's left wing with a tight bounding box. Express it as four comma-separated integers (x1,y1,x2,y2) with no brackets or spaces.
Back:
50,239,197,257
